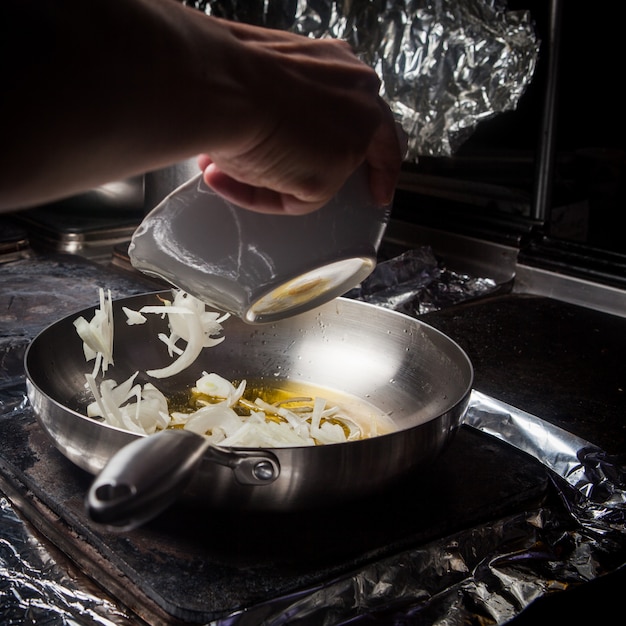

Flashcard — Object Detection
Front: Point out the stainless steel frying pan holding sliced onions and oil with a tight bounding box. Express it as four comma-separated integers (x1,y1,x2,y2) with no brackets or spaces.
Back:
25,292,473,527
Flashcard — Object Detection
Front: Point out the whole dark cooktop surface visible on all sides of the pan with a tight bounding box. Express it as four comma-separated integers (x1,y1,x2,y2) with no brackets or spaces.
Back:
0,250,626,623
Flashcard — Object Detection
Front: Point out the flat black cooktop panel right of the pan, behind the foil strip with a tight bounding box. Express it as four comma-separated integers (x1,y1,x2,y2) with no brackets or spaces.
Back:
421,294,626,454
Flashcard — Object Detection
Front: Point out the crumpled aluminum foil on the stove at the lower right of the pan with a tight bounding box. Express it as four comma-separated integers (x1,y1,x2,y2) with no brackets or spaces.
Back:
213,391,626,626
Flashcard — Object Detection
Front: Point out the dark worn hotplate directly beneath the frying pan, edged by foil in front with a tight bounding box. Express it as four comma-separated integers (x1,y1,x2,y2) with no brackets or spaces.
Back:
0,410,547,623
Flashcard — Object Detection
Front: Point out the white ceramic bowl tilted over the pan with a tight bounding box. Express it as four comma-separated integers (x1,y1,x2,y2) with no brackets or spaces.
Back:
129,167,389,324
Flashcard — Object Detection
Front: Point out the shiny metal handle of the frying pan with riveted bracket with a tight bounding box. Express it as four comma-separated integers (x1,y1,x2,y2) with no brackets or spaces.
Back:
85,429,280,530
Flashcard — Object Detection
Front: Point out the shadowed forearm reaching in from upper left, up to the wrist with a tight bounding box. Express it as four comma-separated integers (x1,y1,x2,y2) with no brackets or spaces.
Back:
0,0,248,209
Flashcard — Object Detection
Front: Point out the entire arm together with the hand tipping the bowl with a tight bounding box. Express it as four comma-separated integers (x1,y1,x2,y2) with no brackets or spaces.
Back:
0,0,402,213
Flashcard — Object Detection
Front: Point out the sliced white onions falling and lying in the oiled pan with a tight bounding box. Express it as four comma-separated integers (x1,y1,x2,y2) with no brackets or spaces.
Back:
74,289,395,447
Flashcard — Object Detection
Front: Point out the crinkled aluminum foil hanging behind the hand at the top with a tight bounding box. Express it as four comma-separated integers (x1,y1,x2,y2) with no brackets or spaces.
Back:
184,0,540,160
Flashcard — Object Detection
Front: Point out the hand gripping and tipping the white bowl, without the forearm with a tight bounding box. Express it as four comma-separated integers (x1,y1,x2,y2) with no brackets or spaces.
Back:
198,20,403,215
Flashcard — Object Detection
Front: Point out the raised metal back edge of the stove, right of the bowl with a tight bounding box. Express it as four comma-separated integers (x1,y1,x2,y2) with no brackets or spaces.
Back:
385,219,626,317
